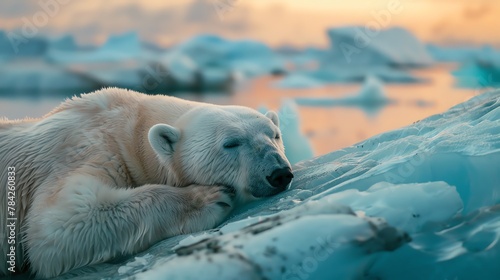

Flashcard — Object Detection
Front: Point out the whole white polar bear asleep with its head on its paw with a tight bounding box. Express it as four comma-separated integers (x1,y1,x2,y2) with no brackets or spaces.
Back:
0,88,293,278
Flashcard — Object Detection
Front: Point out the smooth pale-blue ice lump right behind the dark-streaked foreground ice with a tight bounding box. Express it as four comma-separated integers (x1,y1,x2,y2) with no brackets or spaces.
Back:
328,182,463,233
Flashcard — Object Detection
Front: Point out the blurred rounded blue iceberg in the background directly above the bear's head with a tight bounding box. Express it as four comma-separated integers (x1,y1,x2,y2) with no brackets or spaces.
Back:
154,35,284,91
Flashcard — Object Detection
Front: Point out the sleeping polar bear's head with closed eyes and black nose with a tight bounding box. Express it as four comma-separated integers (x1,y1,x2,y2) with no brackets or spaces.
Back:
148,105,293,199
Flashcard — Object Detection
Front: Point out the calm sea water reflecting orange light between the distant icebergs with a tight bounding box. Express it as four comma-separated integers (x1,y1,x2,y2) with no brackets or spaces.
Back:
0,65,482,158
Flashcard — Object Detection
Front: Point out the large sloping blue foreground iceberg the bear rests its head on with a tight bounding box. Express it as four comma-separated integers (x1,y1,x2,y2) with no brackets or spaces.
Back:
48,91,500,279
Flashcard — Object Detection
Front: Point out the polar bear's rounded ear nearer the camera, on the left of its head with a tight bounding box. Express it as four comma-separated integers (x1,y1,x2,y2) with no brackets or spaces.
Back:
148,124,181,156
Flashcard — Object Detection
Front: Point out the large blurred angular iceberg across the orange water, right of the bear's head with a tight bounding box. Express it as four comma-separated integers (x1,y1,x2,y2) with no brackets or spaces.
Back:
277,26,434,88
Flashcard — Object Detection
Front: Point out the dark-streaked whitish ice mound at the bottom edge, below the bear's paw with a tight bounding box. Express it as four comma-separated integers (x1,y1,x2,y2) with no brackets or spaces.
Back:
137,201,409,279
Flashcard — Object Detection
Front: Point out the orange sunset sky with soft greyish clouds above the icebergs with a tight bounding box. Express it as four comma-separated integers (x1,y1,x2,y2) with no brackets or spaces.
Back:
0,0,500,47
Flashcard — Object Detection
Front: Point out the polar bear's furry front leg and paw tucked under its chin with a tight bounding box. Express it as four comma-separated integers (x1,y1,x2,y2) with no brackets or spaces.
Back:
25,175,234,278
